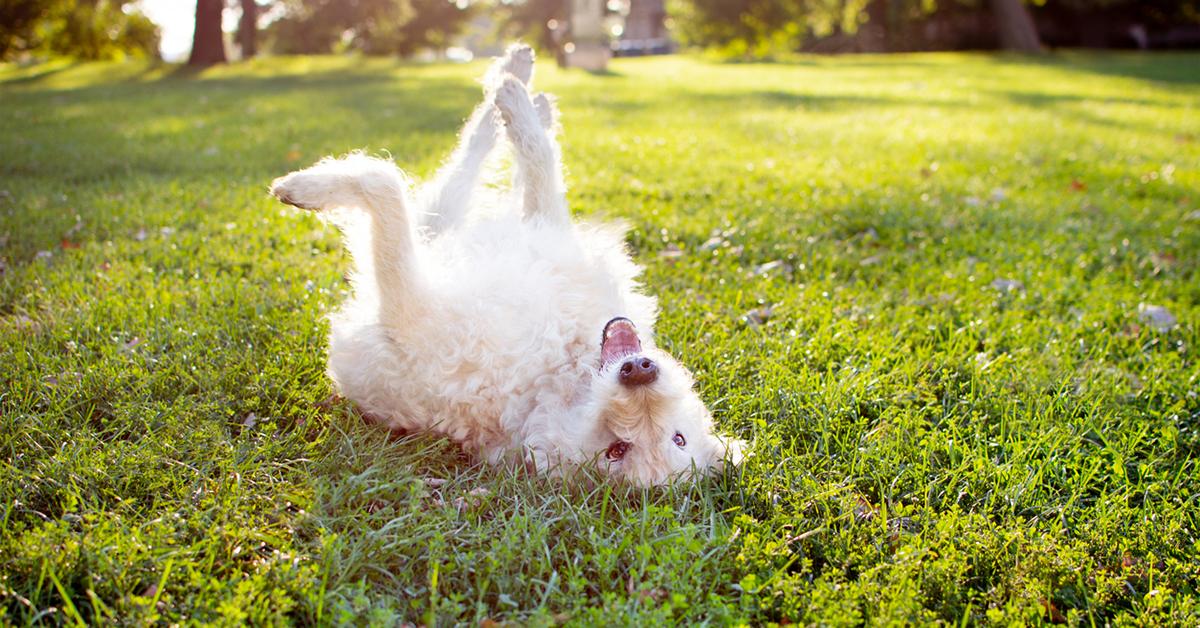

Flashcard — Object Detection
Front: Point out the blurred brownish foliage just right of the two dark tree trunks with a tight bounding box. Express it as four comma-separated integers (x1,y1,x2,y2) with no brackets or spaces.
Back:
266,0,472,56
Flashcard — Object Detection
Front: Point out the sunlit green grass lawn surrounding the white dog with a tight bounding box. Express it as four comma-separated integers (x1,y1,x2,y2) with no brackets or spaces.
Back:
0,55,1200,626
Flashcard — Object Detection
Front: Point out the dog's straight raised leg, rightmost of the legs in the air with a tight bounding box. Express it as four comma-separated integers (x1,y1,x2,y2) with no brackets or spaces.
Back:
496,76,570,225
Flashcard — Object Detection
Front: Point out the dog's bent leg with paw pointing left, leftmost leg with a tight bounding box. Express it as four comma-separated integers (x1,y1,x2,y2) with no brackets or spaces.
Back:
271,154,425,328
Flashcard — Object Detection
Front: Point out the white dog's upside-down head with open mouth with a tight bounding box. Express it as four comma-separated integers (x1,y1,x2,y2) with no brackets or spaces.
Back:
590,318,744,486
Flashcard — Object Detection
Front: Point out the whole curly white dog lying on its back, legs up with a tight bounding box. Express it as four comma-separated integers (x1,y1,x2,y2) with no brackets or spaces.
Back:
271,46,743,485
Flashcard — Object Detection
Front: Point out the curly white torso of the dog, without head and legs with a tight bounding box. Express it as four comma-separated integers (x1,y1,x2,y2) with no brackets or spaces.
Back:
329,221,654,460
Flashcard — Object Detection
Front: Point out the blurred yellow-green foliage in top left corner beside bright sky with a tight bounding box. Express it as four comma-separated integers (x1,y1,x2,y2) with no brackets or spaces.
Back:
0,0,158,60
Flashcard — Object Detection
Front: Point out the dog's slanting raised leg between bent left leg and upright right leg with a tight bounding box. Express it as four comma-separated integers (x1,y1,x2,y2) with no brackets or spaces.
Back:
418,44,533,238
